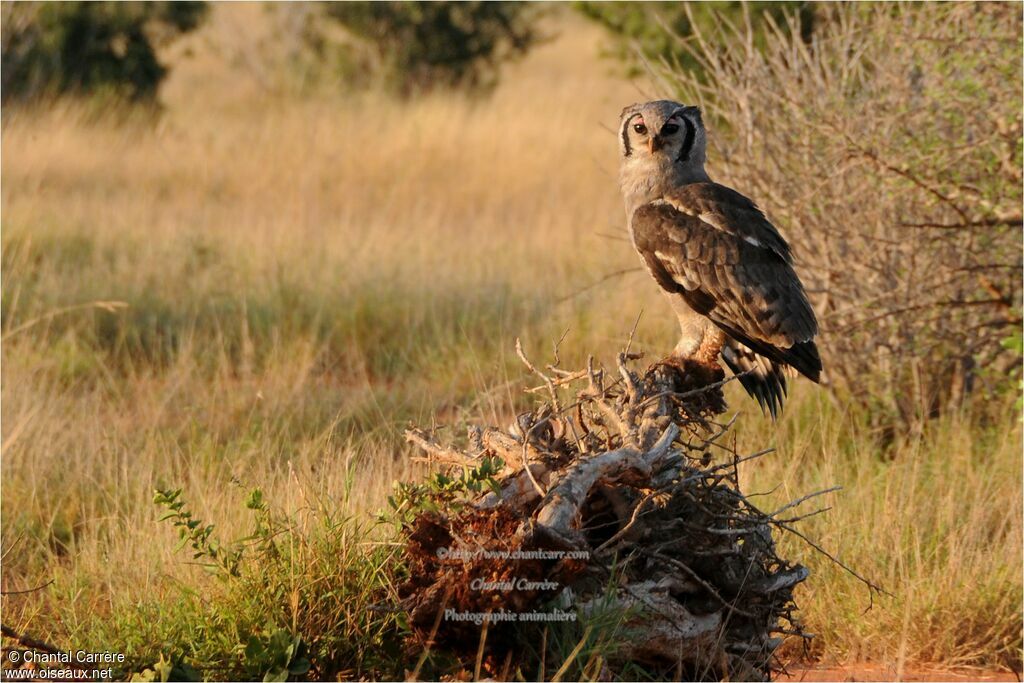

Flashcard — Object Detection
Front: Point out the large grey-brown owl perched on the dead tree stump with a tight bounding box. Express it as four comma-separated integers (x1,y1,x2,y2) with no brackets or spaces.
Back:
618,99,821,419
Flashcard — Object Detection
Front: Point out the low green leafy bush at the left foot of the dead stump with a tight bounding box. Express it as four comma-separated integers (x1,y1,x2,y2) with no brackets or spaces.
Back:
143,489,403,681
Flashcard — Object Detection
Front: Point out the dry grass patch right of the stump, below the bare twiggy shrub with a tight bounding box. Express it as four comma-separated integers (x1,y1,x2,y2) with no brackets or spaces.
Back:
739,387,1024,671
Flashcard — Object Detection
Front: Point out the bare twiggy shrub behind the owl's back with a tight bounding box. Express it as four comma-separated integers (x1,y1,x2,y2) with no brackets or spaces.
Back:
664,3,1022,422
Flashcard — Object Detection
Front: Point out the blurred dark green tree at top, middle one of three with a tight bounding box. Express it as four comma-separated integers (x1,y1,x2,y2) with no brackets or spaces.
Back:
319,1,541,96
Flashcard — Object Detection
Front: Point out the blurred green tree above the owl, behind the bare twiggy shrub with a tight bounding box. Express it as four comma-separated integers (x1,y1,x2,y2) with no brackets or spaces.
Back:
573,1,814,76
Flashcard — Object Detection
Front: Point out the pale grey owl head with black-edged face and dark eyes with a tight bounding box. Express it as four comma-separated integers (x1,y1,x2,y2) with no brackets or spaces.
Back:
618,99,707,189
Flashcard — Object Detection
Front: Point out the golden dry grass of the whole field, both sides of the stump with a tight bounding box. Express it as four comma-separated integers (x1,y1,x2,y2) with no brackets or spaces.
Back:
0,5,1022,679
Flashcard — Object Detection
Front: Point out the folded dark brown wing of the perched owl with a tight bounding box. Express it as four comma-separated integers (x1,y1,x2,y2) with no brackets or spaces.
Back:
631,182,821,391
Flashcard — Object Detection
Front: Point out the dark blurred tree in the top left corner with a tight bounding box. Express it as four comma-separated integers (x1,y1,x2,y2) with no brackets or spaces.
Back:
0,2,206,101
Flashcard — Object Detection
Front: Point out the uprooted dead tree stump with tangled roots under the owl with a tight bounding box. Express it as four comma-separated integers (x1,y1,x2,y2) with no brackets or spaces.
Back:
399,349,824,680
